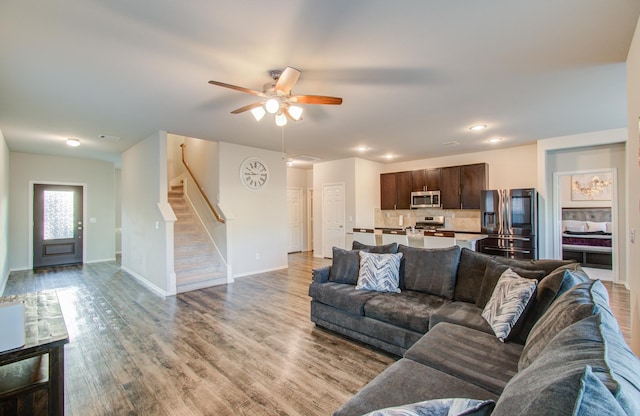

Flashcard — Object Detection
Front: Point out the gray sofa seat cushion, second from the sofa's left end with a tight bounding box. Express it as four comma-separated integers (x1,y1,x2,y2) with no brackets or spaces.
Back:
364,290,451,334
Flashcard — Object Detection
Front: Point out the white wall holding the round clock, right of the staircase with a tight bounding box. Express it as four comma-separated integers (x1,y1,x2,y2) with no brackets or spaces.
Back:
217,142,288,278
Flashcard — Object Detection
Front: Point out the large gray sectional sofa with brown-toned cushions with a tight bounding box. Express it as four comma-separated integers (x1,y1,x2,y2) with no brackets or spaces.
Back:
309,245,640,416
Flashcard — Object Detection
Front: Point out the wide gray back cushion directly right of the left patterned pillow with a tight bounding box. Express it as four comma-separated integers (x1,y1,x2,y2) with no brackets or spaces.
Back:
398,244,460,299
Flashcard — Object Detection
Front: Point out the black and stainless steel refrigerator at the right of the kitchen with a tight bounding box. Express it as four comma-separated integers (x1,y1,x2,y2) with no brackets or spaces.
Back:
478,188,538,259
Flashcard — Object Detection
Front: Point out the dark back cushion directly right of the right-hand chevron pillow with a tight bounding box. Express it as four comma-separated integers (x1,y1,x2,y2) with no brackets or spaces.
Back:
507,263,589,344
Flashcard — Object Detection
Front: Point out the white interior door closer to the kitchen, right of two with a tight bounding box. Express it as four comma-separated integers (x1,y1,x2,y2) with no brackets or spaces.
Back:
322,184,345,258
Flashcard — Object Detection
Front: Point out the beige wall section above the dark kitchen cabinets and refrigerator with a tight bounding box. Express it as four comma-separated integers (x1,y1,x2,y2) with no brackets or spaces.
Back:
383,144,537,189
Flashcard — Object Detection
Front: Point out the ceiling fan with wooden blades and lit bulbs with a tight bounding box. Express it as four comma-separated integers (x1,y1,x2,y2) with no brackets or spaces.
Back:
209,66,342,126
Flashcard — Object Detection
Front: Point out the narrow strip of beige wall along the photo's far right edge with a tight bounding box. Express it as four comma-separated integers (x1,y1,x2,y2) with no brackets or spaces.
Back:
625,16,640,355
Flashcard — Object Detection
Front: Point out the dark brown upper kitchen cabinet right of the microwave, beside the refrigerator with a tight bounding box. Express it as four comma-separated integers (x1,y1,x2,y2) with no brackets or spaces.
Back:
440,163,488,209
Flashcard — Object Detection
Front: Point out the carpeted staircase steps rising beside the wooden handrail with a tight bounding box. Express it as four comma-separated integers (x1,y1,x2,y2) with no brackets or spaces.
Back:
169,186,227,293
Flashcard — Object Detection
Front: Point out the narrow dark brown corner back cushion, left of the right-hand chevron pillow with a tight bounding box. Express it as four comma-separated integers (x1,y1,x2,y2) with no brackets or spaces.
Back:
453,248,491,303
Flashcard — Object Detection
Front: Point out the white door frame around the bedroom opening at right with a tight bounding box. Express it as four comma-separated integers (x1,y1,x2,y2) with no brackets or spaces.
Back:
551,168,627,284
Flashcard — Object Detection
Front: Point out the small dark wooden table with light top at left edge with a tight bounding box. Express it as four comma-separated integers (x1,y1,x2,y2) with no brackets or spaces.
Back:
0,290,69,415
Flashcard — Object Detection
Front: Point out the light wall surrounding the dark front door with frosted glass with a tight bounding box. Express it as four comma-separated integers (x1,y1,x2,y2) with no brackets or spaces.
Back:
9,152,116,270
